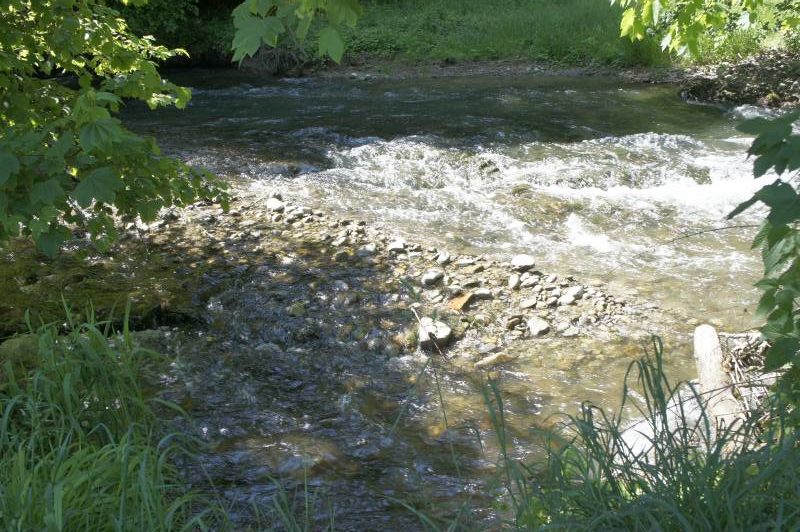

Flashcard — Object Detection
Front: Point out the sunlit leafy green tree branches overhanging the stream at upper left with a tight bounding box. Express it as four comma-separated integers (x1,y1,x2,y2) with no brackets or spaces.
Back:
0,0,224,254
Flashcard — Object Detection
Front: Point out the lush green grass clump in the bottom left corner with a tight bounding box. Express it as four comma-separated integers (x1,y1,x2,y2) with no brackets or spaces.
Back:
0,314,219,531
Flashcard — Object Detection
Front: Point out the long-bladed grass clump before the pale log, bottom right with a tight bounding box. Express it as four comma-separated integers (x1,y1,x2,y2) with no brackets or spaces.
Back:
478,341,800,530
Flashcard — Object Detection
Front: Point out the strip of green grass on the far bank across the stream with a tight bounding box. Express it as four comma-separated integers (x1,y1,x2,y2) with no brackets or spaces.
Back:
345,0,667,66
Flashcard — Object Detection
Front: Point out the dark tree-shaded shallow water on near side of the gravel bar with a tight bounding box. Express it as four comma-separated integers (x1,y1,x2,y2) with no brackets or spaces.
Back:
0,198,552,530
